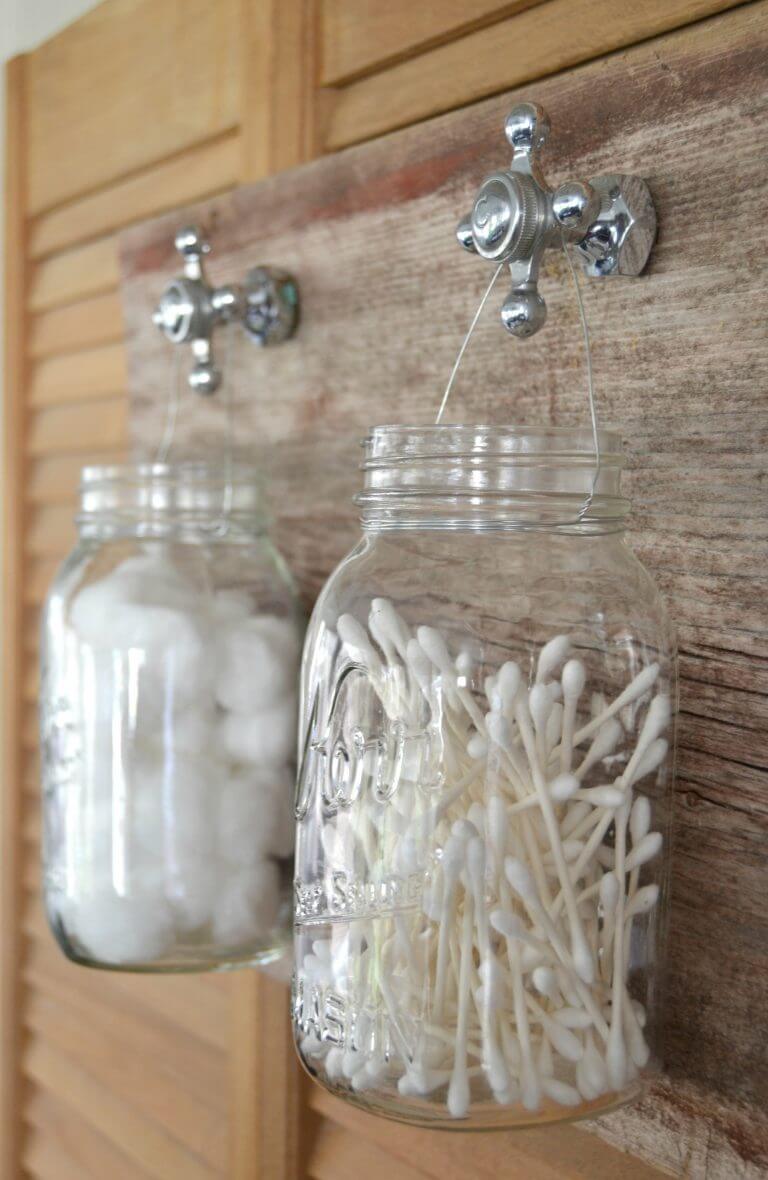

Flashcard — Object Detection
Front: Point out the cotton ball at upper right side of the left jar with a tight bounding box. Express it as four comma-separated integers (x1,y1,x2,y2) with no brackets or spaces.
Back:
216,615,298,713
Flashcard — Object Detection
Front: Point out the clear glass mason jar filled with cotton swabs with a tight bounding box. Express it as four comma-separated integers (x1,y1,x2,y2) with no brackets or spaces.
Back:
293,426,675,1129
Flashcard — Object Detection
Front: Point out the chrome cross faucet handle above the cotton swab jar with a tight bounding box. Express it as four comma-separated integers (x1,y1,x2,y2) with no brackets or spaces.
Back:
457,103,656,339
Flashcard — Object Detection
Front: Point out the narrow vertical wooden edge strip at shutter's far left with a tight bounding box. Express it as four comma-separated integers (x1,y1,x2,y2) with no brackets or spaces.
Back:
0,58,27,1178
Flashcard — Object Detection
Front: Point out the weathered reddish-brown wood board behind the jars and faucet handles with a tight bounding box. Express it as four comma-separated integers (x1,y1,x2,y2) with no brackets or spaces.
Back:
122,0,768,1180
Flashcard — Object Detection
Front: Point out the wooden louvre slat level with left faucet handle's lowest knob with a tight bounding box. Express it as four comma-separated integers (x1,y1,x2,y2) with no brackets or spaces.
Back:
27,343,126,406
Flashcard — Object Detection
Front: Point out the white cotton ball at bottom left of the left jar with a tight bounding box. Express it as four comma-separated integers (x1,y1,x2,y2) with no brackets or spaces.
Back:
67,890,173,964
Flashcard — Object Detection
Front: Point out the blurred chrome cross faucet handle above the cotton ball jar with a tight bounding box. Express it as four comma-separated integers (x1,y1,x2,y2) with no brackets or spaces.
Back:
152,225,298,394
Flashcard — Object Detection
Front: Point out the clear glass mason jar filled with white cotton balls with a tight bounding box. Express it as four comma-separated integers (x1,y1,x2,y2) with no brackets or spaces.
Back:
41,464,303,971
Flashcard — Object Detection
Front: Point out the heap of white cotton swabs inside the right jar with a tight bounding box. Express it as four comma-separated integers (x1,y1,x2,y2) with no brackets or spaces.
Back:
297,598,670,1119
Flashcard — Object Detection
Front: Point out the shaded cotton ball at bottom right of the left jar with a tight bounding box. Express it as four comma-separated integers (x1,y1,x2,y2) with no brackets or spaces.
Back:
214,860,280,946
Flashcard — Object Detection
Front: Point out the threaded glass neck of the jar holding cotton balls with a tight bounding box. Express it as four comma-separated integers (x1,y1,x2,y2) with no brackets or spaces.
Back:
77,463,267,543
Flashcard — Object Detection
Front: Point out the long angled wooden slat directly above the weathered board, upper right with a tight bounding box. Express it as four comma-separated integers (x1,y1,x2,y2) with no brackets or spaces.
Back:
323,0,740,151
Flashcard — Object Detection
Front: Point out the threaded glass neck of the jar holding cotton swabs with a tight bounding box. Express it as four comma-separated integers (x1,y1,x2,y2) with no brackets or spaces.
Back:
356,426,629,536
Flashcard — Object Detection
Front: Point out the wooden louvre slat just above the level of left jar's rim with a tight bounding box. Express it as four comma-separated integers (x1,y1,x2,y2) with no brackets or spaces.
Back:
28,398,127,457
